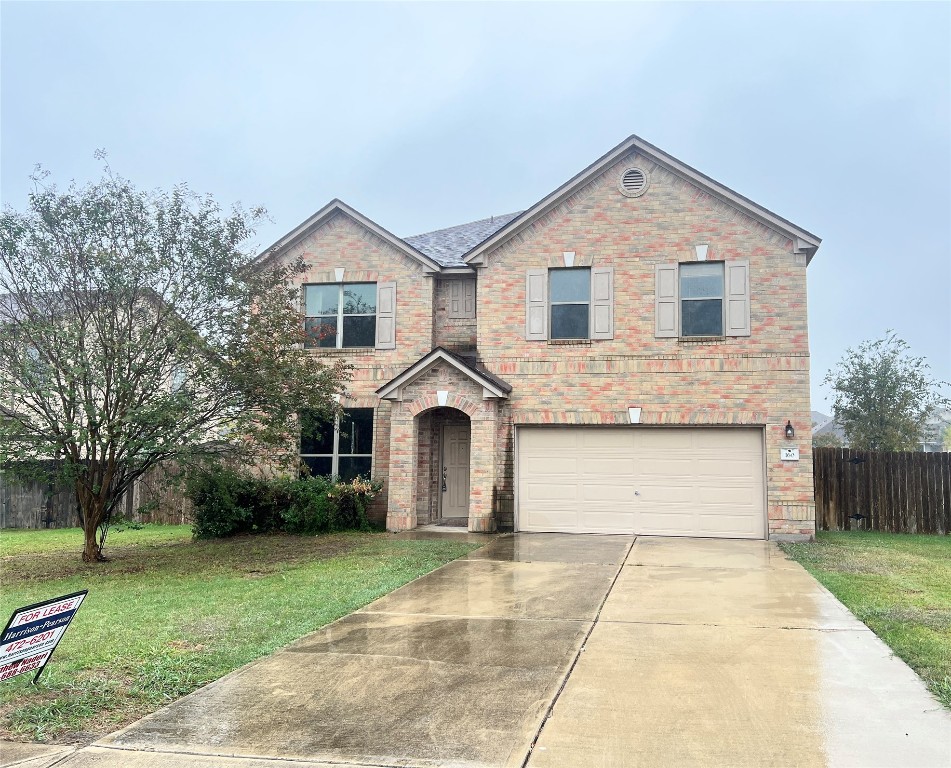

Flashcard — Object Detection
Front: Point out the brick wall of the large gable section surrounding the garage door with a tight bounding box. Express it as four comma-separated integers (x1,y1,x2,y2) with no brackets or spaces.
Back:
478,150,814,535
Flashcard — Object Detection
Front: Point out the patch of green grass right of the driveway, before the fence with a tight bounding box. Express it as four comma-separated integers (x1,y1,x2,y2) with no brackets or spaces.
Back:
781,532,951,708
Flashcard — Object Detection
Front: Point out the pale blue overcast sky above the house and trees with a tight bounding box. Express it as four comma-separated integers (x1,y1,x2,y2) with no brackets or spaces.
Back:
0,0,951,413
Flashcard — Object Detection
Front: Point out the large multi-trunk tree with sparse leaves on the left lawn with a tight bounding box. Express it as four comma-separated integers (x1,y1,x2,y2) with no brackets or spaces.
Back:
0,168,349,561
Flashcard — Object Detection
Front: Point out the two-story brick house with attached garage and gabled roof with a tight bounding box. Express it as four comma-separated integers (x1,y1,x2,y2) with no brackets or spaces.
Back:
259,136,820,539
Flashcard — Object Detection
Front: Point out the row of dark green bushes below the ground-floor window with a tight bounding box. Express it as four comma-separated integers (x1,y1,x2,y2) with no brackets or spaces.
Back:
186,467,381,539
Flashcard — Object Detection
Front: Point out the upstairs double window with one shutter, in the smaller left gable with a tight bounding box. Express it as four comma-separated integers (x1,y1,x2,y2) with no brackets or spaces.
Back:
304,283,377,349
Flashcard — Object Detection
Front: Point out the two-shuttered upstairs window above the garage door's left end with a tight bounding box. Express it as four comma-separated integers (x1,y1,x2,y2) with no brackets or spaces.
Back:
525,267,614,341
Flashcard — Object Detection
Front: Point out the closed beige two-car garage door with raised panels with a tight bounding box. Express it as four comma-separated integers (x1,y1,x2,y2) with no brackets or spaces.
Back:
517,427,766,539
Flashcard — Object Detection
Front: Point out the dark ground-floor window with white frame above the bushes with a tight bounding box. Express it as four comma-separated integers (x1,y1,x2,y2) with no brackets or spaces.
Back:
300,408,373,482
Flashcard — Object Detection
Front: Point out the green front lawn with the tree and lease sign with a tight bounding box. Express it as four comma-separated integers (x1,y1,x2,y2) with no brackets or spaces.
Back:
0,526,475,742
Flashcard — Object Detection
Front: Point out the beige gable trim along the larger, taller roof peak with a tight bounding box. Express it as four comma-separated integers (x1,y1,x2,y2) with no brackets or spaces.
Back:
465,135,822,264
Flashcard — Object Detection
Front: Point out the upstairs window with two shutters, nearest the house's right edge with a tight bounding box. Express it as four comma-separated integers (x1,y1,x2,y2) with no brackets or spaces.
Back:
654,261,750,338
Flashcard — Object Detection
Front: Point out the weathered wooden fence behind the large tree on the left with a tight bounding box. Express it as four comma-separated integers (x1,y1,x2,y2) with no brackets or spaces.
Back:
0,465,191,528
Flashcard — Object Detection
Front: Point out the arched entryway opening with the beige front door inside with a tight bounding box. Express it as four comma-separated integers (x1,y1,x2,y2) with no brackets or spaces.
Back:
416,407,472,528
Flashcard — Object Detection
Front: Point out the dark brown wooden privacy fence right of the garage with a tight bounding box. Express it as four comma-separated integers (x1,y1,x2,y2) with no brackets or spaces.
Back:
812,448,951,534
